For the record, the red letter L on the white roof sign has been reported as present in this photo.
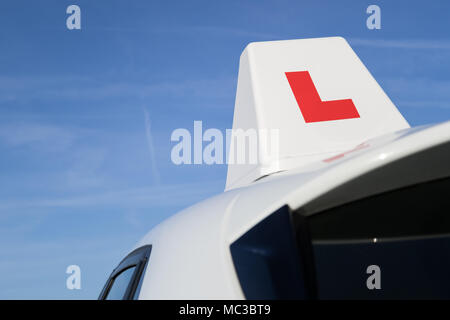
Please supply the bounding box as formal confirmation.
[286,71,359,123]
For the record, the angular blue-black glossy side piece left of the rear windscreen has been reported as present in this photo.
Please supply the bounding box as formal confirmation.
[230,206,306,299]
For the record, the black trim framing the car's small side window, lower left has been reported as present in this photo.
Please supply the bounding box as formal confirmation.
[98,245,152,300]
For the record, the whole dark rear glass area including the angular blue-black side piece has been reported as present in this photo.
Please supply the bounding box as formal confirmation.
[230,177,450,299]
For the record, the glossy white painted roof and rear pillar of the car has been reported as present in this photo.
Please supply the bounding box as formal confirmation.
[119,39,450,299]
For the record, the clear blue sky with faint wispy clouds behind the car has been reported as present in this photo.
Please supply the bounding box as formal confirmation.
[0,0,450,299]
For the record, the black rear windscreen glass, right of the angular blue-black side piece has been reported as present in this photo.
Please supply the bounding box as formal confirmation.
[299,178,450,299]
